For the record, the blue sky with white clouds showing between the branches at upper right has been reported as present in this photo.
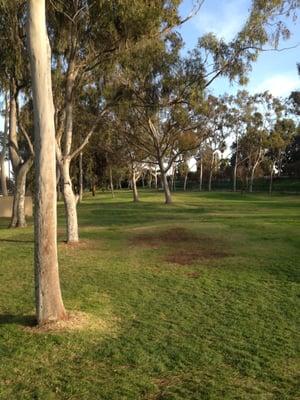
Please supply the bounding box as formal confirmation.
[180,0,300,97]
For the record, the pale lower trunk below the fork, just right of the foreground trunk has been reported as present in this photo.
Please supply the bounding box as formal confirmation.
[59,158,79,243]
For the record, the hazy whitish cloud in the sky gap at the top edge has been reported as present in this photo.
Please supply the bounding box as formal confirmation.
[193,0,249,41]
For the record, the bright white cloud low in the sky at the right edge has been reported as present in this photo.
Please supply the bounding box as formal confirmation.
[251,74,300,97]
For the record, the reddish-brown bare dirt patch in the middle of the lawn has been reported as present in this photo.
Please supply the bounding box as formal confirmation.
[130,227,230,265]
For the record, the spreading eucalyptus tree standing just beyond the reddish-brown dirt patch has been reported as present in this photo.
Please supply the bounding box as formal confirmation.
[113,41,210,204]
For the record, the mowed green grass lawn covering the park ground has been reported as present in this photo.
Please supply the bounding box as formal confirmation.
[0,191,300,400]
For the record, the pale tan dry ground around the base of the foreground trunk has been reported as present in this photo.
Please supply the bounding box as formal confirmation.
[24,311,112,333]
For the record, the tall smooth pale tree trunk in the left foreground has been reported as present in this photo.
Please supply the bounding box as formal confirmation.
[28,0,67,325]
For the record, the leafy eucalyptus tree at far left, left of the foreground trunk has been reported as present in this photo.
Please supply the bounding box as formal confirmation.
[0,0,33,227]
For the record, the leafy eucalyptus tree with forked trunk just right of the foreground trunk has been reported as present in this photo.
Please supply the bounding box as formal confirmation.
[45,0,186,242]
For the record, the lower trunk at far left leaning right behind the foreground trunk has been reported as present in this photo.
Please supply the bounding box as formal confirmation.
[10,158,33,228]
